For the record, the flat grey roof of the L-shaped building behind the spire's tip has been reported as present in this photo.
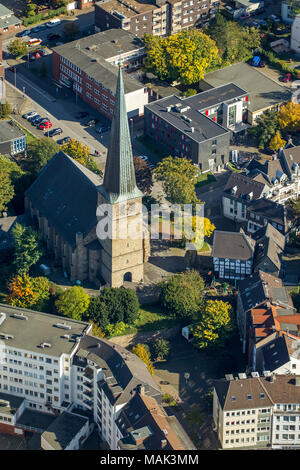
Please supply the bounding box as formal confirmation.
[53,29,144,93]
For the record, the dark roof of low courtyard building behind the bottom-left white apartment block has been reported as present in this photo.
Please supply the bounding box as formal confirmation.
[42,411,88,450]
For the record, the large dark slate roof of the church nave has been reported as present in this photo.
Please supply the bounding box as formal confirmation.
[25,151,102,248]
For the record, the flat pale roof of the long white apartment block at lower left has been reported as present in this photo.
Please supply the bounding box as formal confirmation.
[0,303,89,357]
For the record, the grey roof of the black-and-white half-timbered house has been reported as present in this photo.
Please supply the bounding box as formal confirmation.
[212,230,255,260]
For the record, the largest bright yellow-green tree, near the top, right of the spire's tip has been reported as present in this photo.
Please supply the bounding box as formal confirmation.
[144,29,220,85]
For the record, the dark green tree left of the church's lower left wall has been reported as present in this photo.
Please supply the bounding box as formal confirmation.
[11,224,43,274]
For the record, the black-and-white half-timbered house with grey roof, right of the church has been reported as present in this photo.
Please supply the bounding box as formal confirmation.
[211,230,255,279]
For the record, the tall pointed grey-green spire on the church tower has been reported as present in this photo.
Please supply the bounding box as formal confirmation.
[102,66,143,204]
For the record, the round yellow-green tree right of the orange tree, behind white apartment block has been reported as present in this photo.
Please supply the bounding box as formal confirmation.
[55,286,90,320]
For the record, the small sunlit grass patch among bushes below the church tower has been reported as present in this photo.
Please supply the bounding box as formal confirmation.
[114,303,178,335]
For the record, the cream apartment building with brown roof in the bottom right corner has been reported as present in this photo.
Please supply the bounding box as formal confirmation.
[213,371,300,449]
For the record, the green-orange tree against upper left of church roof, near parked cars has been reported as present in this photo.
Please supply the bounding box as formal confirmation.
[27,137,59,174]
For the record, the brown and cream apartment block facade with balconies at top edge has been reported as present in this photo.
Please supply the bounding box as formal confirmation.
[95,0,214,38]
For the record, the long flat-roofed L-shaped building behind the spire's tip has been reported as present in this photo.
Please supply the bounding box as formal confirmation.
[52,29,148,120]
